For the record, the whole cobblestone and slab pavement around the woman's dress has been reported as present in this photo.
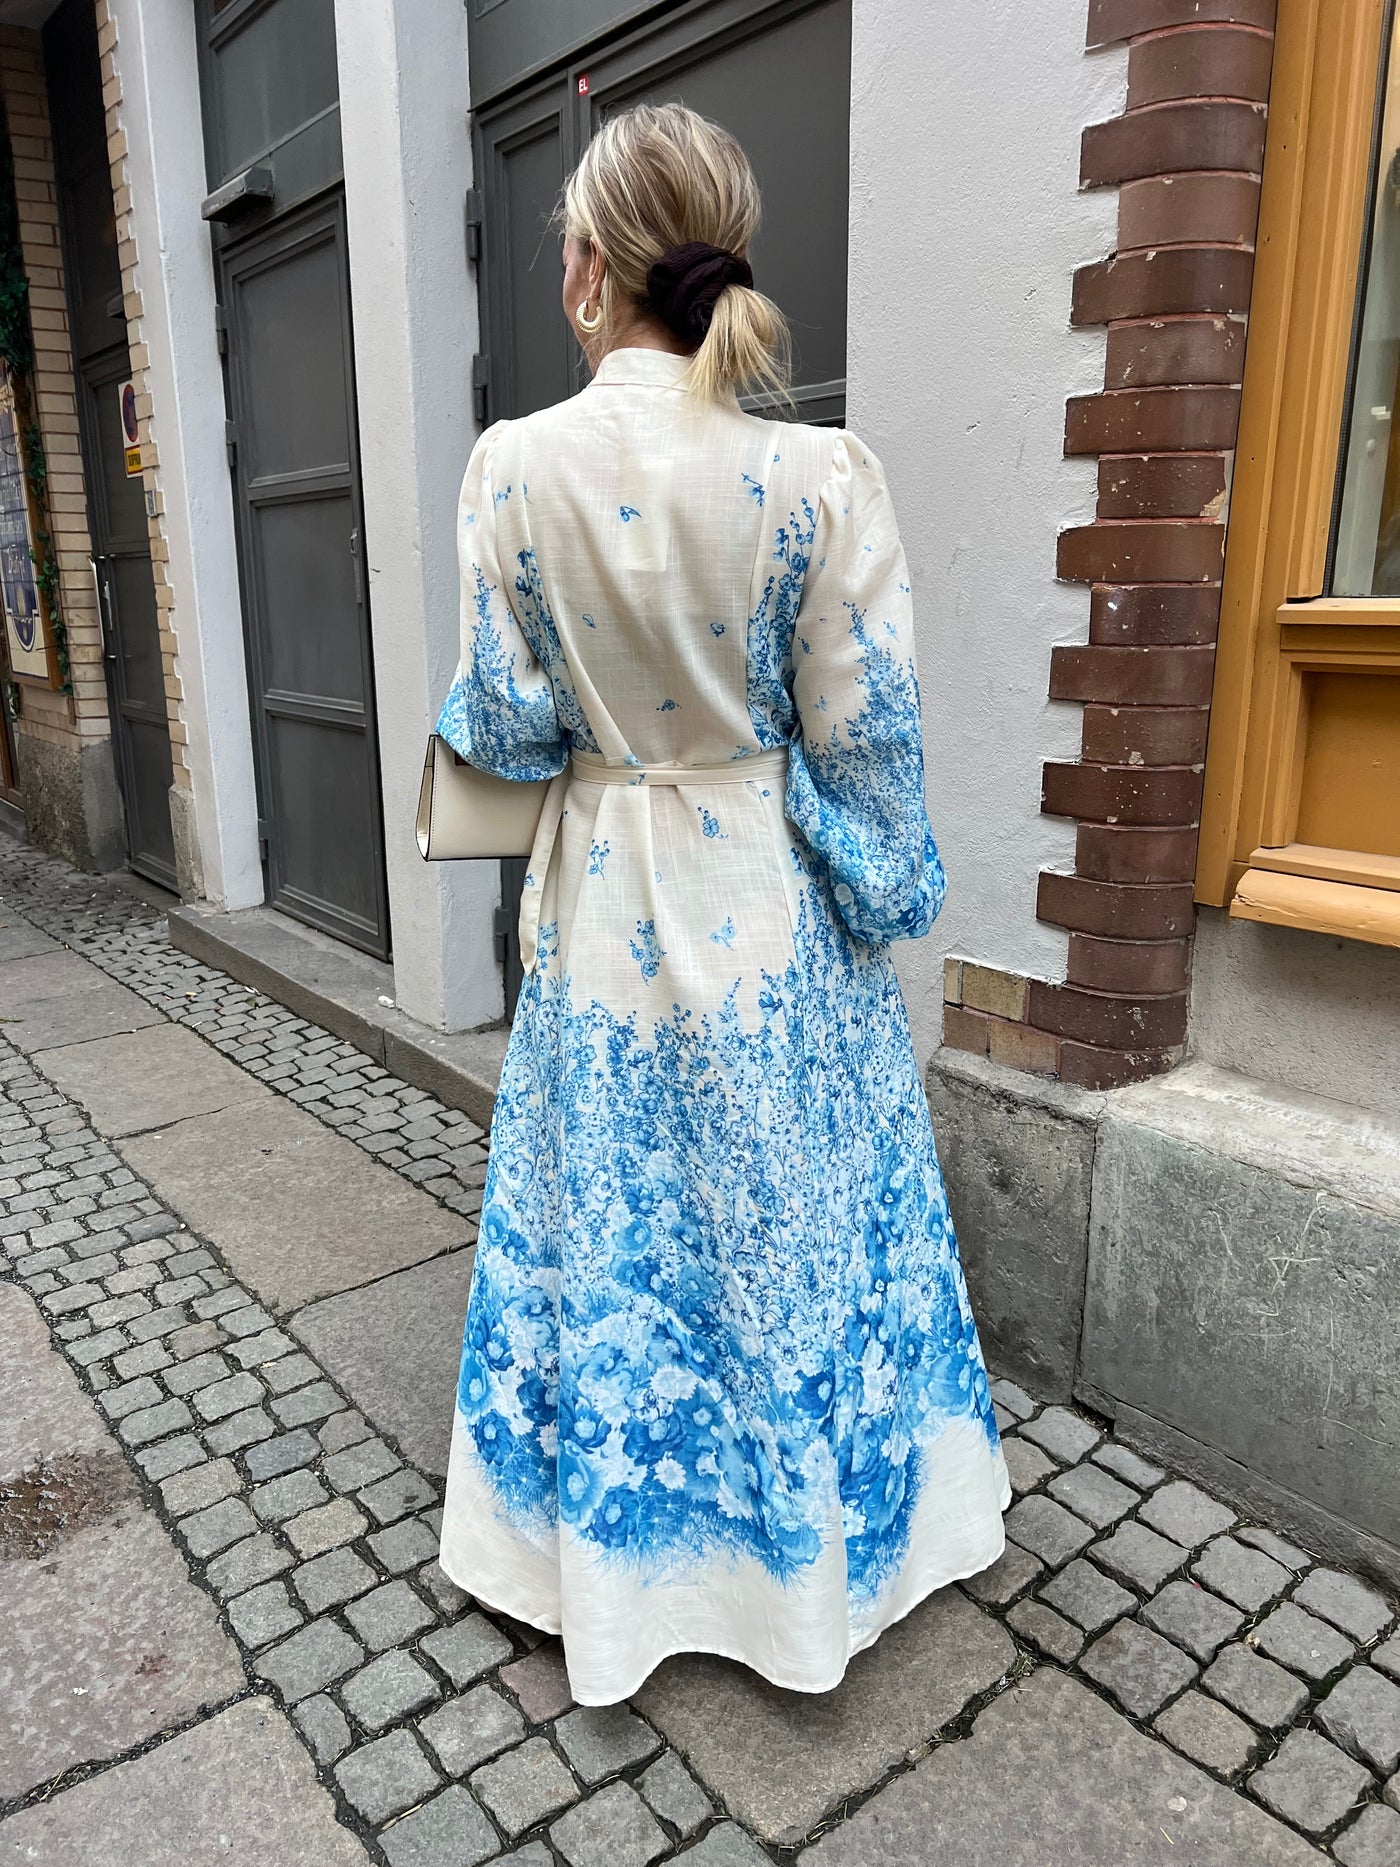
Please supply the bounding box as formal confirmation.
[0,842,1400,1867]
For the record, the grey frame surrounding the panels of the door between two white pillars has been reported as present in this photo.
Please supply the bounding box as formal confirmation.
[215,181,390,960]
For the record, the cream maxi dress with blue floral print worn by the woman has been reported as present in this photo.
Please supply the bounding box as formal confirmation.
[439,349,1010,1705]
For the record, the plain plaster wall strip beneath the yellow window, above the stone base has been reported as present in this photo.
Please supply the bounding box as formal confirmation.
[1189,907,1400,1116]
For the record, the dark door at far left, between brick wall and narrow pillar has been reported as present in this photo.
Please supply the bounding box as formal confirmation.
[43,0,175,889]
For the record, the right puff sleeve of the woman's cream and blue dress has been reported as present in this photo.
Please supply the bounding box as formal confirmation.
[786,433,945,941]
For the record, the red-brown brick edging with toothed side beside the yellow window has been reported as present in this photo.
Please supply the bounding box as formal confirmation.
[945,0,1273,1088]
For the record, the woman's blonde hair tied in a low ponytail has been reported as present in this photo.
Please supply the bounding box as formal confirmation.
[560,105,791,401]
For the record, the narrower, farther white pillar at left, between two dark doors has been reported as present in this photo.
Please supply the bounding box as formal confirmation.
[110,0,263,907]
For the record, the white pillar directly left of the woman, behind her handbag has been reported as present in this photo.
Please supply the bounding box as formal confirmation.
[336,0,504,1031]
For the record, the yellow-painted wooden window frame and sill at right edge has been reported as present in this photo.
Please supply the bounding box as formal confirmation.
[1197,0,1400,947]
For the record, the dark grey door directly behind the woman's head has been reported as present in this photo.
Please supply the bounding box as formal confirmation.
[470,0,851,1008]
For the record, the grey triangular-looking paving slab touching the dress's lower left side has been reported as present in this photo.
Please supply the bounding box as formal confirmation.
[291,1251,474,1477]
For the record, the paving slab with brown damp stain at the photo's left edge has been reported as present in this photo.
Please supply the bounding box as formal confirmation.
[0,1286,245,1799]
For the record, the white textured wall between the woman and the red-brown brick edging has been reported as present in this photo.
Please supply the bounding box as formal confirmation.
[849,0,1126,1060]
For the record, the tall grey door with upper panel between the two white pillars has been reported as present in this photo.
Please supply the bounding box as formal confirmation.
[200,0,388,958]
